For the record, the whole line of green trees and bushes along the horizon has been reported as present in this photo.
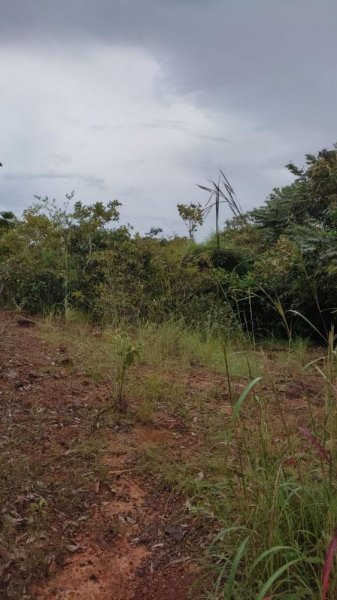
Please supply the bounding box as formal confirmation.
[0,146,337,339]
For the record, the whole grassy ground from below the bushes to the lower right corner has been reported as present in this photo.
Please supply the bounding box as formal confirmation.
[25,319,337,600]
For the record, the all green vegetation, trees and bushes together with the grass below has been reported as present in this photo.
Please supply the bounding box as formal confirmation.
[0,146,337,600]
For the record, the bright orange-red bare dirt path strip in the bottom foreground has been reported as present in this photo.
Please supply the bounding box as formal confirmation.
[36,426,197,600]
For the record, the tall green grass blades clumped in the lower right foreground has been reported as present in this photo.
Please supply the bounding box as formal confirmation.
[201,322,337,600]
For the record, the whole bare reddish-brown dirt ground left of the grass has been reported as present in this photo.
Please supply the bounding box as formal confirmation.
[0,313,201,600]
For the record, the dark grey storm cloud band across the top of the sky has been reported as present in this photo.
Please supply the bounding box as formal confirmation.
[0,0,337,155]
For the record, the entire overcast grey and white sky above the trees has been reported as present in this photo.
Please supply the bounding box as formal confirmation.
[0,0,337,234]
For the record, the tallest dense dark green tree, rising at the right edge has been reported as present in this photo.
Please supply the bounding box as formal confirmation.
[219,146,337,336]
